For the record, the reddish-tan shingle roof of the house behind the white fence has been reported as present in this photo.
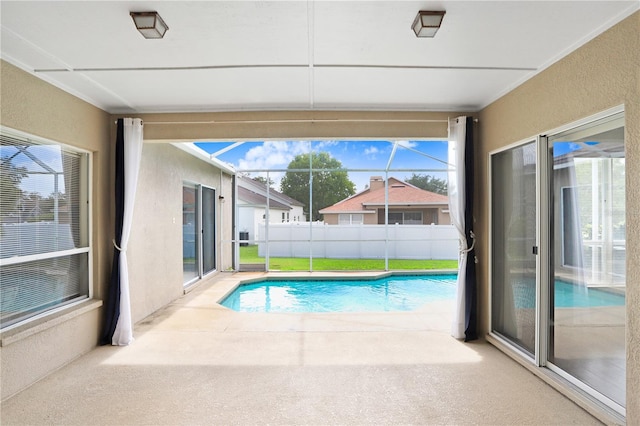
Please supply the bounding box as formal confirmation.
[320,177,449,214]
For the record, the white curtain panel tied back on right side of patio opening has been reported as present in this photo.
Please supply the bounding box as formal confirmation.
[448,116,468,339]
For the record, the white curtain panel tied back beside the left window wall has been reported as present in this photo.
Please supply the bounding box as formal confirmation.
[111,118,143,346]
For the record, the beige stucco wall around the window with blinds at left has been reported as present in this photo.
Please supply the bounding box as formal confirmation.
[0,61,112,399]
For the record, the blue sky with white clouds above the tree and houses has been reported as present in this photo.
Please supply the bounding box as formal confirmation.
[196,140,448,191]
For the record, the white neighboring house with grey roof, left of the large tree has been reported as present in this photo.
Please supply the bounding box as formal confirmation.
[237,176,307,240]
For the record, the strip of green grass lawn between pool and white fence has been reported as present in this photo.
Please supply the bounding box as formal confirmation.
[240,245,458,271]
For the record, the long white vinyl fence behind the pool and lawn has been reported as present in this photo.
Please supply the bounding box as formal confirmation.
[257,222,459,260]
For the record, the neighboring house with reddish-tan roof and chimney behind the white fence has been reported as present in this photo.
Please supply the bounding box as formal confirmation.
[320,176,451,225]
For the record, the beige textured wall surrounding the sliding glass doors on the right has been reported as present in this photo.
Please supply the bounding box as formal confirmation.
[475,12,640,424]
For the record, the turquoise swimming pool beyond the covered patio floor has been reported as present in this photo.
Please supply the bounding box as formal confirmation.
[220,274,457,312]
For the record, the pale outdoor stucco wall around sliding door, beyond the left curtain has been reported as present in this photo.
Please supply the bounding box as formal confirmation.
[127,143,233,322]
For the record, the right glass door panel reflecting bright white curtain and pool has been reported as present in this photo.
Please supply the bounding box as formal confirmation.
[548,118,626,407]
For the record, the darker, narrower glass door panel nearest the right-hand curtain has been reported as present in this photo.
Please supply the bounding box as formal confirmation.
[491,142,537,357]
